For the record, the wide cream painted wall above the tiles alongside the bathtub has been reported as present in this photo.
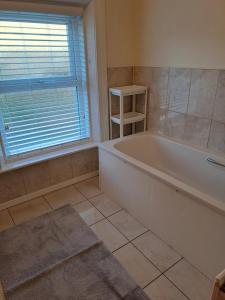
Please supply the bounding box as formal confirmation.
[134,0,225,69]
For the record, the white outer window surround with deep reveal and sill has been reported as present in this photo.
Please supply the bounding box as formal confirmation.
[0,0,109,173]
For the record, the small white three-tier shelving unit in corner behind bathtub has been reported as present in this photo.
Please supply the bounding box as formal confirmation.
[109,85,148,139]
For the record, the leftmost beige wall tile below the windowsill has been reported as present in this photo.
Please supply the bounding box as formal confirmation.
[0,170,26,203]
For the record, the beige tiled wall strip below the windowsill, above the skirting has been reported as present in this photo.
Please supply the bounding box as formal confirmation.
[0,148,98,204]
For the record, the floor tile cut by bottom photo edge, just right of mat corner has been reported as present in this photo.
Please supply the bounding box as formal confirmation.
[144,275,188,300]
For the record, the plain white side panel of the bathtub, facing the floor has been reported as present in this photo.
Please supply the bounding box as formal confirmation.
[100,149,225,279]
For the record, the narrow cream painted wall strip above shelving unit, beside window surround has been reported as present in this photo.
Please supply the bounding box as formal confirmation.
[106,0,135,67]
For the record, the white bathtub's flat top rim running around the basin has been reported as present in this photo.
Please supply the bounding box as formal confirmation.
[99,132,225,216]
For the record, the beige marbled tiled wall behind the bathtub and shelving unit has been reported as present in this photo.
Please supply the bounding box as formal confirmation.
[108,67,225,153]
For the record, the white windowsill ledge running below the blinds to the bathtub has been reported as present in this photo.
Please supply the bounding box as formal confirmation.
[0,141,98,174]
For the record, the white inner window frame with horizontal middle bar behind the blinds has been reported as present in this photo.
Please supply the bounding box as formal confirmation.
[0,11,93,166]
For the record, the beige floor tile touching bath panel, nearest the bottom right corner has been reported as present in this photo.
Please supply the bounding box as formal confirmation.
[165,260,213,300]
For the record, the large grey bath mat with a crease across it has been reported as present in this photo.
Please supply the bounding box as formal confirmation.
[0,206,151,300]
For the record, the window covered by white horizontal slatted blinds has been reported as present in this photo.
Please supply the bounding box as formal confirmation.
[0,12,90,159]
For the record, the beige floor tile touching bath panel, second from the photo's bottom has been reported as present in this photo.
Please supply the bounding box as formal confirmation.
[132,232,181,272]
